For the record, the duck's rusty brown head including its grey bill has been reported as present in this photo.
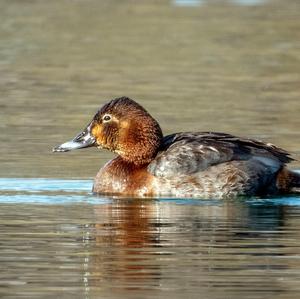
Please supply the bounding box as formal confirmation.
[54,97,162,165]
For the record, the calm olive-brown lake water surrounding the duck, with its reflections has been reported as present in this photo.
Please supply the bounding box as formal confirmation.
[0,0,300,299]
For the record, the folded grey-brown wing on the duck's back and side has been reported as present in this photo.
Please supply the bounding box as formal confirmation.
[148,132,293,177]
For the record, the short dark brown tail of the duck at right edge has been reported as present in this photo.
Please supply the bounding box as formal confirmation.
[276,167,300,193]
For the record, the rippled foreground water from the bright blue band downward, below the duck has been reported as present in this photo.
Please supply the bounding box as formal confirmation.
[0,179,300,299]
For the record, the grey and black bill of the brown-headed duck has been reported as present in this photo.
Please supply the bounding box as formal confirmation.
[53,123,96,152]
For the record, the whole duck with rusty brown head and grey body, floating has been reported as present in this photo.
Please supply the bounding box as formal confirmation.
[53,97,300,199]
